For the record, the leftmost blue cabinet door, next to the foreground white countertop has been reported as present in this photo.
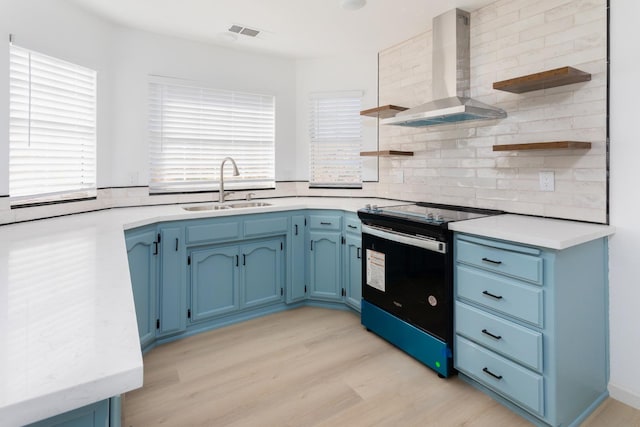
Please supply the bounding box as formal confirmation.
[126,226,158,348]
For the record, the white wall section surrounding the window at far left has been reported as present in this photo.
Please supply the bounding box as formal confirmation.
[0,0,112,195]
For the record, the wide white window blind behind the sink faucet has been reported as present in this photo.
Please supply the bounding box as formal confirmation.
[149,78,275,193]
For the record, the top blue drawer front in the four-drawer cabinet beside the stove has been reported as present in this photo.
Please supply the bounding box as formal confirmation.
[456,240,542,285]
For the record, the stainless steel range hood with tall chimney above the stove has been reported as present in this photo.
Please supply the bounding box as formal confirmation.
[380,9,507,127]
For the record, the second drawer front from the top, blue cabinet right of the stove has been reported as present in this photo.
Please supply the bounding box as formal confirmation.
[455,264,543,327]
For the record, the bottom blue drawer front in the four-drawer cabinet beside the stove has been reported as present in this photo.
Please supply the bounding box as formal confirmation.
[454,335,544,416]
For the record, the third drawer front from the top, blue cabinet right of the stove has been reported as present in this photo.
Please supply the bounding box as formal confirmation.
[455,302,542,373]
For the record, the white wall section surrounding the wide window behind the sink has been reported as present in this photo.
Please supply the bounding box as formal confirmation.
[111,28,298,186]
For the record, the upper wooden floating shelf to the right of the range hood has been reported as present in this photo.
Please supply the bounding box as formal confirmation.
[493,67,591,93]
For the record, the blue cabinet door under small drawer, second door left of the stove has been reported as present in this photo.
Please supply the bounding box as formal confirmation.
[309,231,342,301]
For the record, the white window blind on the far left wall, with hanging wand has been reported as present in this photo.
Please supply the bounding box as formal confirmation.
[9,44,96,205]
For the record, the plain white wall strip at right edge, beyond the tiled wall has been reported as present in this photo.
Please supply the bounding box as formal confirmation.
[609,0,640,408]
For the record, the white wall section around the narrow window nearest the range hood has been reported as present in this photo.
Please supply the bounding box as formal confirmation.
[292,52,378,181]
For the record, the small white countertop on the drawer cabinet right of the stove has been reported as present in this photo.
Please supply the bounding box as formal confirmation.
[449,214,615,250]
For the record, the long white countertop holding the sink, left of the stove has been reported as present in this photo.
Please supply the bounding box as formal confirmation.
[0,198,397,427]
